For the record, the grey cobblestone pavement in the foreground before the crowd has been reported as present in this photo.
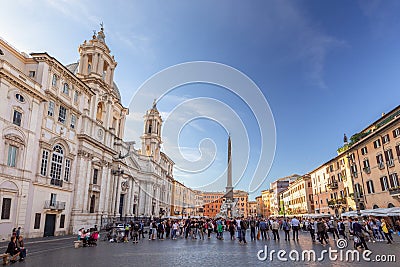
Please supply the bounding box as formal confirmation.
[14,231,400,267]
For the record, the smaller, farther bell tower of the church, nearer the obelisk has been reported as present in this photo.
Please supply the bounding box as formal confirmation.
[141,100,162,162]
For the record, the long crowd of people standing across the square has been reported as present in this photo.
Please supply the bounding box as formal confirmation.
[101,217,400,249]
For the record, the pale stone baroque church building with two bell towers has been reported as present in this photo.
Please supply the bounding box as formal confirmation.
[0,27,176,239]
